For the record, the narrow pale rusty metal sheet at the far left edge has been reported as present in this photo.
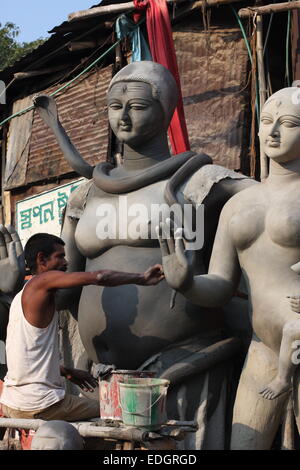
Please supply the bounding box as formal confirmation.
[4,96,33,189]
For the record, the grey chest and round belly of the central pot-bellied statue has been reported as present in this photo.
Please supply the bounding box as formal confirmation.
[75,181,218,369]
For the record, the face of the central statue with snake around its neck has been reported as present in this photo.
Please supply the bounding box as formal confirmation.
[107,82,164,148]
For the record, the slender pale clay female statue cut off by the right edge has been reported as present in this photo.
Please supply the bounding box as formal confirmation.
[162,87,300,449]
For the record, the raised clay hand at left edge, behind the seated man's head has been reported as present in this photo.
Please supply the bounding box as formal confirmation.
[0,225,25,293]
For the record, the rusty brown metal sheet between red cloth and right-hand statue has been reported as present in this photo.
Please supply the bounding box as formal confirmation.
[173,28,249,170]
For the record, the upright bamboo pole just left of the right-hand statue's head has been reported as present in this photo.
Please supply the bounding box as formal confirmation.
[256,15,268,181]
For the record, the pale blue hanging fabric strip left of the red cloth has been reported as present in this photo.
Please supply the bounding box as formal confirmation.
[115,15,152,62]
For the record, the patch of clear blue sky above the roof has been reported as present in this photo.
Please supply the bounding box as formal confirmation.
[0,0,100,42]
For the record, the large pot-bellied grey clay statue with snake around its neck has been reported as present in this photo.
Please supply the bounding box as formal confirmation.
[35,61,254,448]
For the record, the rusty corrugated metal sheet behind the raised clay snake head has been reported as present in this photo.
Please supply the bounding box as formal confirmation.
[26,66,112,184]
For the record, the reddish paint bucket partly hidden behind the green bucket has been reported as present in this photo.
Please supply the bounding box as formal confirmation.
[99,370,155,421]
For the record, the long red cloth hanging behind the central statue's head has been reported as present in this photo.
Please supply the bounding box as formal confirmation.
[133,0,190,155]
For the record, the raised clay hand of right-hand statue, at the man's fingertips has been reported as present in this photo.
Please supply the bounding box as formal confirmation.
[156,219,193,290]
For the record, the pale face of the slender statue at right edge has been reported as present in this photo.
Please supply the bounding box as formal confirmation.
[259,95,300,163]
